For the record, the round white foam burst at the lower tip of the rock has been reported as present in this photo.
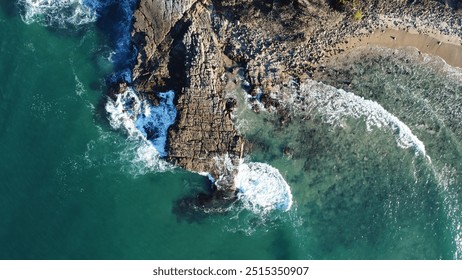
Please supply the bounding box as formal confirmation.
[235,162,292,213]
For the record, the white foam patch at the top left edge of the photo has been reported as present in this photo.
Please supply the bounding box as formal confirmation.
[18,0,98,27]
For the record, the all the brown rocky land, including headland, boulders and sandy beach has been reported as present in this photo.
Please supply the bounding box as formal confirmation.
[114,0,462,196]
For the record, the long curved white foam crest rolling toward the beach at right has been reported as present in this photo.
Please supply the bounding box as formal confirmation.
[296,80,430,160]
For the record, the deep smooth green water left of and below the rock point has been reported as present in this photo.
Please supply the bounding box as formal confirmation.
[0,1,297,259]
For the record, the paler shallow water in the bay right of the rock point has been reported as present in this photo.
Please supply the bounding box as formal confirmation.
[231,44,462,259]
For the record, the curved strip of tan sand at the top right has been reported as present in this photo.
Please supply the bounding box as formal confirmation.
[327,28,462,68]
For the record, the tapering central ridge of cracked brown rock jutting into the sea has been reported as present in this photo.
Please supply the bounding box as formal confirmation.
[168,2,243,189]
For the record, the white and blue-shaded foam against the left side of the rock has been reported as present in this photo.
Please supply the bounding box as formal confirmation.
[106,88,176,171]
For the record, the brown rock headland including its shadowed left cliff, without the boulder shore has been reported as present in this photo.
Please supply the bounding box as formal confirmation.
[133,1,244,193]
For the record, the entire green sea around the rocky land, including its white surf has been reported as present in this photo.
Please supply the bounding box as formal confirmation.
[0,0,462,259]
